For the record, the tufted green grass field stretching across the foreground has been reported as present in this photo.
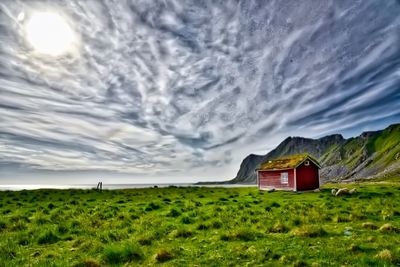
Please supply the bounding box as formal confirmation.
[0,179,400,266]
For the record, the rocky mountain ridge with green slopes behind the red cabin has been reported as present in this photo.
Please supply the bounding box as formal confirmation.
[229,124,400,184]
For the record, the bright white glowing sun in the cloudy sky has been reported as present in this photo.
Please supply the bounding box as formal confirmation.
[25,12,76,56]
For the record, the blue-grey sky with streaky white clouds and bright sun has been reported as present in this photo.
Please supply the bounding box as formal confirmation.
[0,0,400,184]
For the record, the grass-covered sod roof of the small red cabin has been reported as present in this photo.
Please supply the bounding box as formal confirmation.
[257,154,320,170]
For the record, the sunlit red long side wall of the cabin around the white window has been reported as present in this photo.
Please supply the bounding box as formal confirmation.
[258,169,294,190]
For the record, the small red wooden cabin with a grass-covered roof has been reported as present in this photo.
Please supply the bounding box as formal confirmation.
[256,154,321,191]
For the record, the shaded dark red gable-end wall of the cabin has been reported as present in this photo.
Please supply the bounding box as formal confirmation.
[296,161,319,191]
